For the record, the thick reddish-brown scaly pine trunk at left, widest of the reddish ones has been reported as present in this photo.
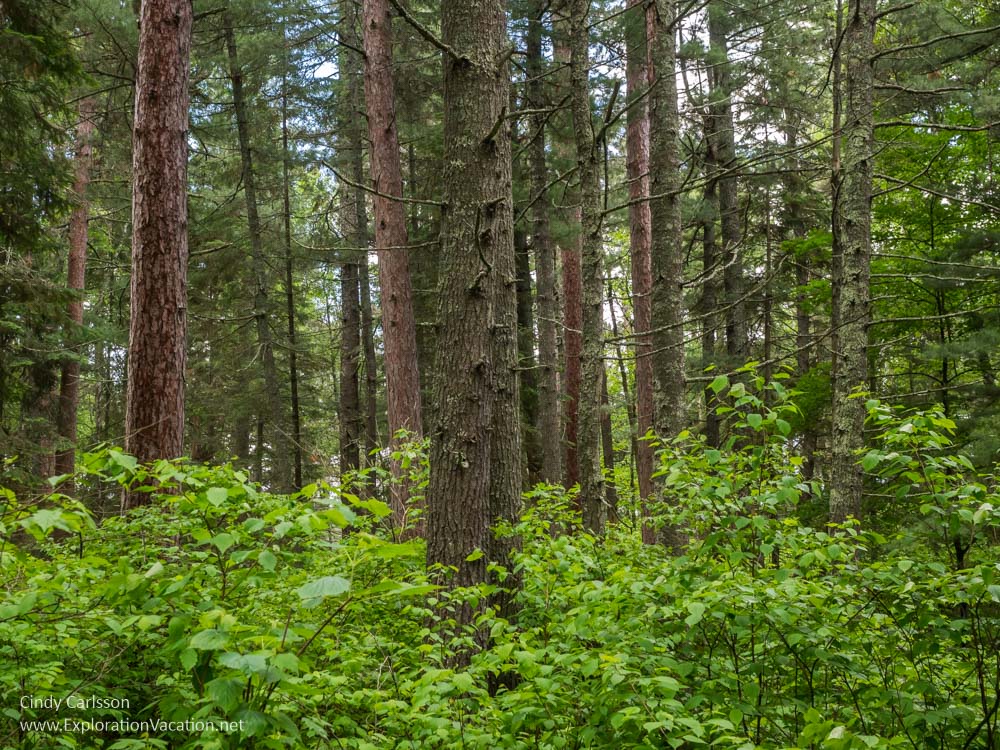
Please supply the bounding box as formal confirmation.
[123,0,192,509]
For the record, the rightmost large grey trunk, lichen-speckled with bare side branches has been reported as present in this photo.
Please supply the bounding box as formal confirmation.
[830,0,876,523]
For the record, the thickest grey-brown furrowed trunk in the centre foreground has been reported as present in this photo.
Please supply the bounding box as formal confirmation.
[427,0,521,622]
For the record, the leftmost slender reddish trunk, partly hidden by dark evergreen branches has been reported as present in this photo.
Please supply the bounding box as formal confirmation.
[55,97,94,482]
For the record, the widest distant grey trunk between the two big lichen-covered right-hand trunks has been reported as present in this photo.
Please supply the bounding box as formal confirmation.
[708,0,749,365]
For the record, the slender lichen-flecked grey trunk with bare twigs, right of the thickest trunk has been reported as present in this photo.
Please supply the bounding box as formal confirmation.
[570,0,607,534]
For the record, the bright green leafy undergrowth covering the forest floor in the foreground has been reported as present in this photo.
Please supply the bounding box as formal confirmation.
[0,400,1000,750]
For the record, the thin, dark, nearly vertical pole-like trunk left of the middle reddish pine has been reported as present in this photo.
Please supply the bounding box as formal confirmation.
[281,32,302,490]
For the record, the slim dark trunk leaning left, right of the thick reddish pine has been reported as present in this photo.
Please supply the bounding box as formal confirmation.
[223,14,290,491]
